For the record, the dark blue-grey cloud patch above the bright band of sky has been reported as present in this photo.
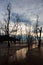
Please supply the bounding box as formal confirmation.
[11,13,31,24]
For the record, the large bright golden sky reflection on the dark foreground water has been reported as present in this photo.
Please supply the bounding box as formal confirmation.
[16,48,28,60]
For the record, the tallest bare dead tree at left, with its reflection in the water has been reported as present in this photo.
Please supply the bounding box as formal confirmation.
[7,3,11,59]
